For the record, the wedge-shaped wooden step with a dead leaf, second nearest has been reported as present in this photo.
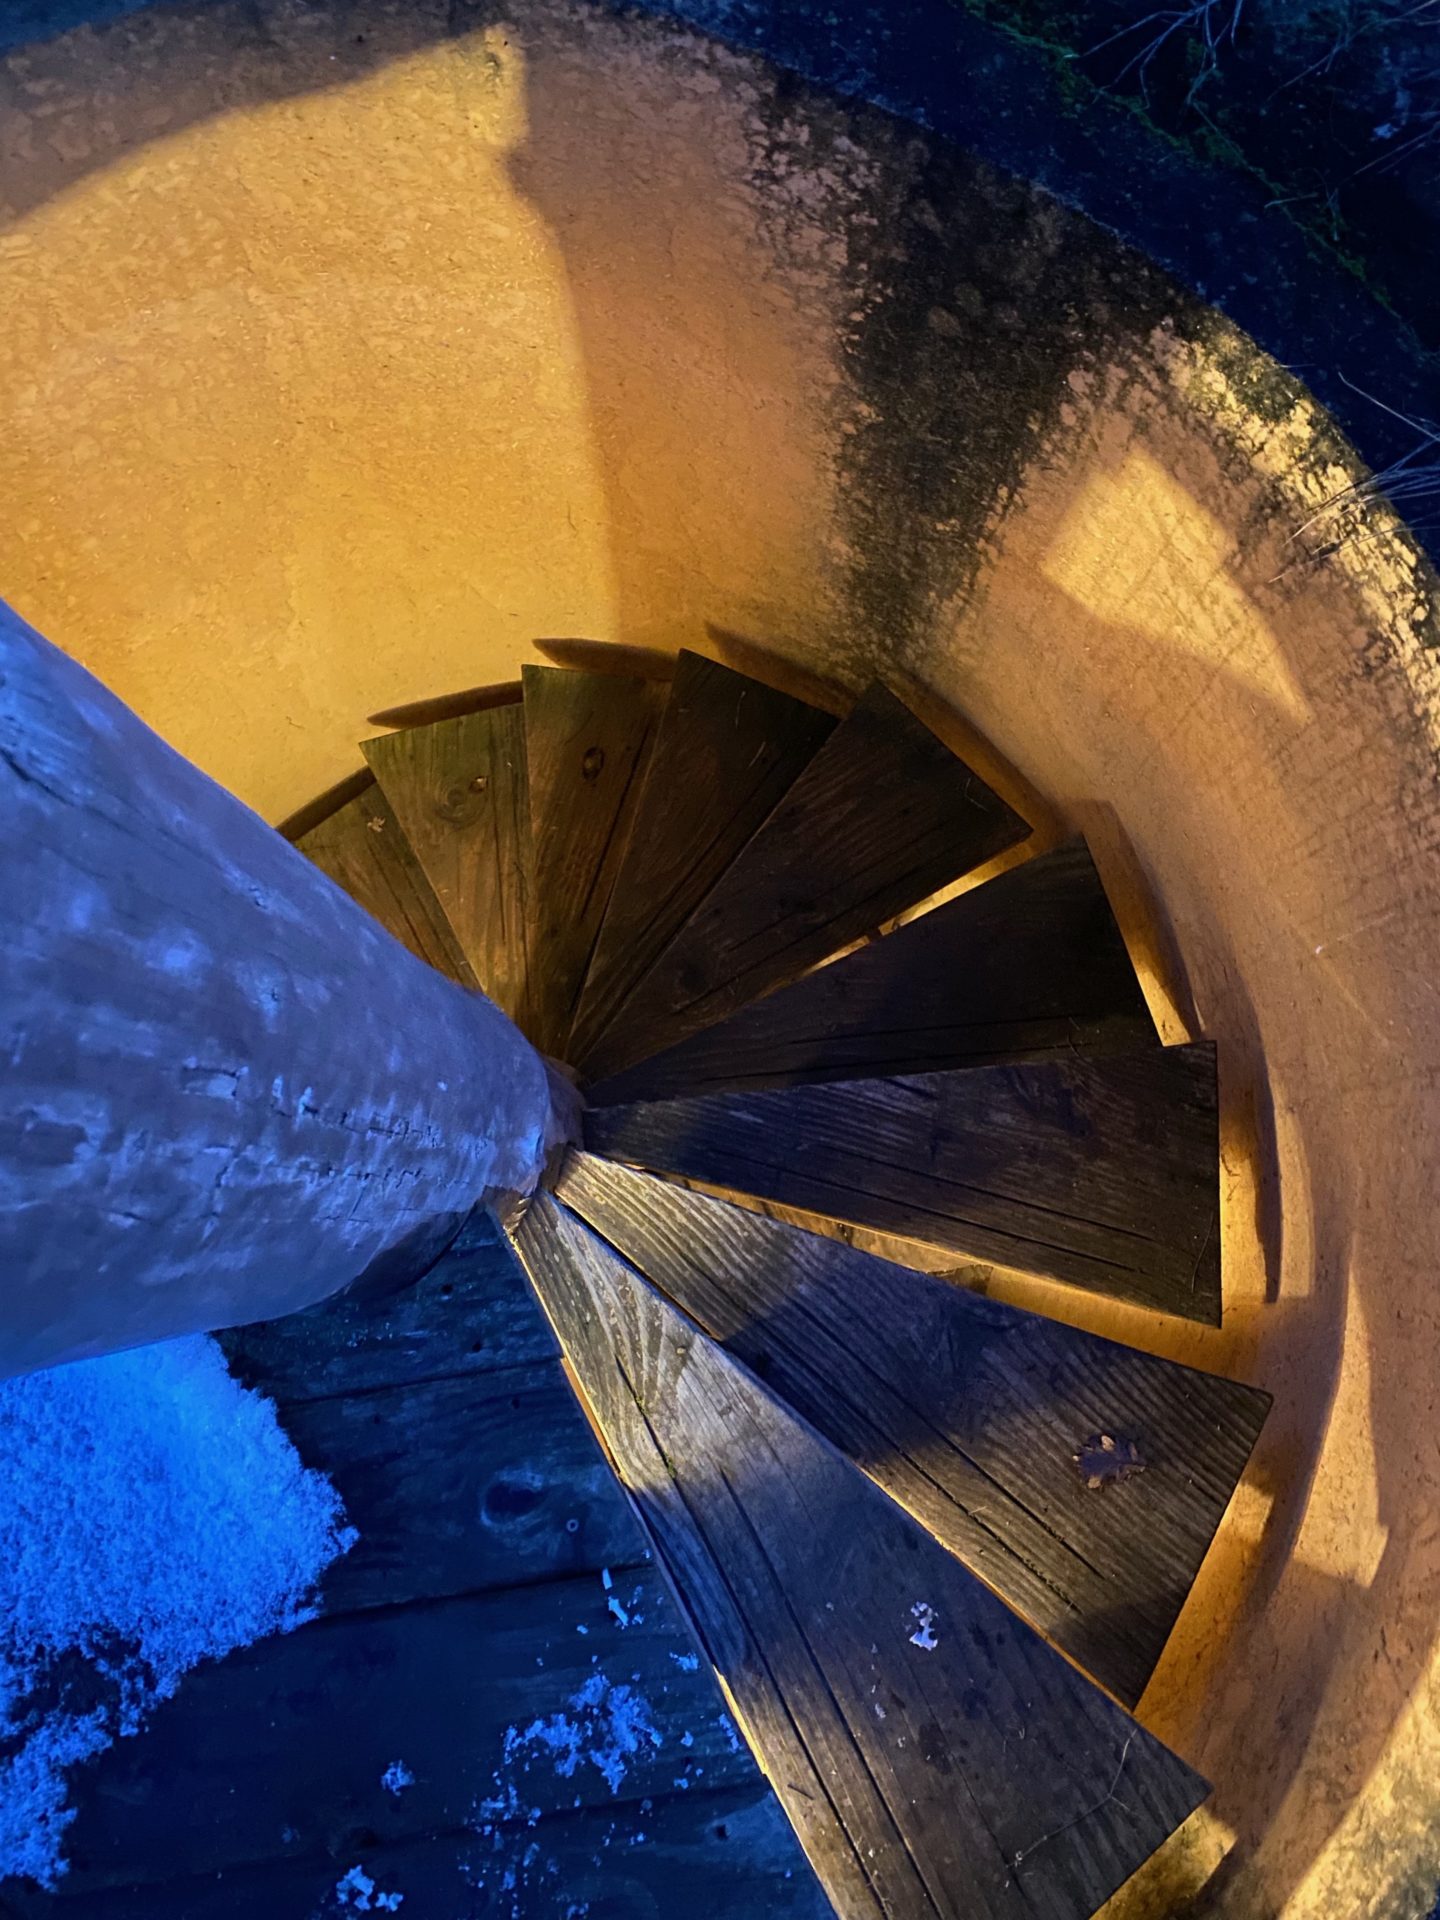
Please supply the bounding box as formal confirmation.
[557,1154,1269,1705]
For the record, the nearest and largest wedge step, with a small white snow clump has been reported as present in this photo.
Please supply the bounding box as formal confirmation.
[516,1194,1206,1920]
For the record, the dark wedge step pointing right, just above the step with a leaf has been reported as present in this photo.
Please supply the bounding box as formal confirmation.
[586,1043,1219,1325]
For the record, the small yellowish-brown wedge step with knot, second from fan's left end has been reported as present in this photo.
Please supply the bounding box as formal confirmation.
[361,705,530,1018]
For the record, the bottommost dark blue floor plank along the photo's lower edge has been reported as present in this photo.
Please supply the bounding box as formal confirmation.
[28,1782,831,1920]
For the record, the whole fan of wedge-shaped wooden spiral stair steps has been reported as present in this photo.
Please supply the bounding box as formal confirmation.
[296,647,1267,1920]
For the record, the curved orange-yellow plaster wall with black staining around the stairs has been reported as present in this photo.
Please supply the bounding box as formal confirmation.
[0,0,1440,1920]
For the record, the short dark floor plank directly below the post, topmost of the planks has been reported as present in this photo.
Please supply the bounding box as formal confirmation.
[219,1215,559,1405]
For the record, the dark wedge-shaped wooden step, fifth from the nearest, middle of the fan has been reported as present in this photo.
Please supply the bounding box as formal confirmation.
[580,684,1029,1081]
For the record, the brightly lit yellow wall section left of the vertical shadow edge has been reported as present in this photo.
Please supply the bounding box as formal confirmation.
[0,4,629,818]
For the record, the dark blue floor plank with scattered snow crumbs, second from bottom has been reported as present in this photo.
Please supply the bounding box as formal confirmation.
[48,1569,756,1895]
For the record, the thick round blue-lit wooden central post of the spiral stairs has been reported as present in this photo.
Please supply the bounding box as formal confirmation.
[0,607,555,1377]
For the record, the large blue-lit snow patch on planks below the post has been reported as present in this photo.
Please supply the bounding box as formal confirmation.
[0,1336,357,1887]
